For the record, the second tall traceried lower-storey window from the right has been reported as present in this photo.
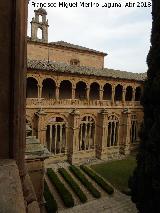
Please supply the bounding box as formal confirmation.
[107,115,119,147]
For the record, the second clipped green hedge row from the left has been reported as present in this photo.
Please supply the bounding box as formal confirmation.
[47,168,74,207]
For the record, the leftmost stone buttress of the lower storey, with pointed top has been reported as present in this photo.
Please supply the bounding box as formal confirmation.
[35,109,46,146]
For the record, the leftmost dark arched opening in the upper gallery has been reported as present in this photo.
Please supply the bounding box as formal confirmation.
[26,77,38,98]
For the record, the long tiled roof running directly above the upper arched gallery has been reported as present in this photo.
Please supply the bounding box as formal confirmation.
[27,60,147,81]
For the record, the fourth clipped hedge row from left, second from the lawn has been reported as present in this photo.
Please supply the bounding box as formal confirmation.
[69,165,101,198]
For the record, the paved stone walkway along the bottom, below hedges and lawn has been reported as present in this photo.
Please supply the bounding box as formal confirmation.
[58,191,138,213]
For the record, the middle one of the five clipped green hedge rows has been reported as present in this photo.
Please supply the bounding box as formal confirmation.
[58,168,87,203]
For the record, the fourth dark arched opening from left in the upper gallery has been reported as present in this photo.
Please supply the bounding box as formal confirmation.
[75,81,87,100]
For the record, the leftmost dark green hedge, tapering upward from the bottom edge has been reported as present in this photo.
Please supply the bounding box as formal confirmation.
[43,181,58,213]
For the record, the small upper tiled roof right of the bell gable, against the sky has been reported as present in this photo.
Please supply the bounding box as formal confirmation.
[49,41,107,56]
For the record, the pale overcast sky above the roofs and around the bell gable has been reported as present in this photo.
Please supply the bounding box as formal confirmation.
[28,0,151,72]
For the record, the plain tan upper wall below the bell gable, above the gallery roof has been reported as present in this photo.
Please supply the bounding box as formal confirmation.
[27,41,104,69]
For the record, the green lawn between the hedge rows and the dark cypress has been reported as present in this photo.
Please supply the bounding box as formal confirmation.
[91,156,136,192]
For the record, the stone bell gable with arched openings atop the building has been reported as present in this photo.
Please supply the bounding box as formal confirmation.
[31,8,49,43]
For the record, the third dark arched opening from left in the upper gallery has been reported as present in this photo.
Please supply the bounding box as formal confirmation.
[59,80,72,99]
